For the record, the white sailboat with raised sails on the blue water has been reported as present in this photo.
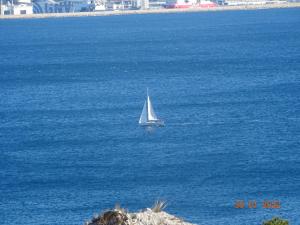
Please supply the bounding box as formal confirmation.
[139,88,165,127]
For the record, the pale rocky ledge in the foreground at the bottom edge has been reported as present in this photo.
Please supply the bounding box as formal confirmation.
[85,208,194,225]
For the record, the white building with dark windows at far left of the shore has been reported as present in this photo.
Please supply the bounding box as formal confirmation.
[0,0,33,15]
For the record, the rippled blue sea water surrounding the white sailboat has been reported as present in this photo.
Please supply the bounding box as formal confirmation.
[0,9,300,225]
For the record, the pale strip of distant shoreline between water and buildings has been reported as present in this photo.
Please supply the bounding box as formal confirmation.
[0,3,300,19]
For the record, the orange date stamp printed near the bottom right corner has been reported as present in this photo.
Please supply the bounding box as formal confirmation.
[234,200,281,209]
